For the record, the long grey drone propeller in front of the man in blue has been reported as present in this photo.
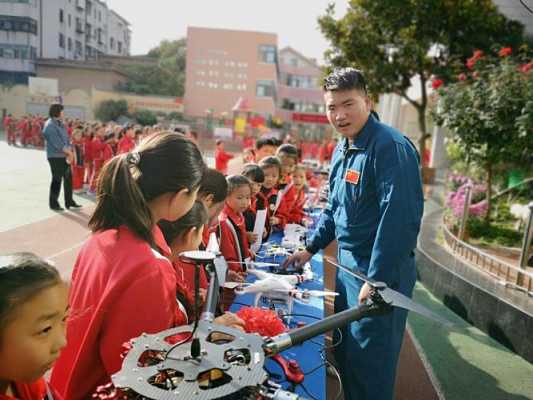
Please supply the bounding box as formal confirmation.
[326,257,452,327]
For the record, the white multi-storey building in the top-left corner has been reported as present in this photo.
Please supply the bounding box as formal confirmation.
[0,0,131,83]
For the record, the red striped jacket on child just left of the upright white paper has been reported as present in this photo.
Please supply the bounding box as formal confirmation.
[219,204,250,272]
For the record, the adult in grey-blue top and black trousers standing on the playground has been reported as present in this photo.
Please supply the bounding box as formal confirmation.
[43,103,81,211]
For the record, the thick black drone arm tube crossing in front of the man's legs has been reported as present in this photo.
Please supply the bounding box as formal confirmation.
[264,303,391,356]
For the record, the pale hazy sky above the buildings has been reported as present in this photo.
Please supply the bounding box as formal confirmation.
[107,0,348,61]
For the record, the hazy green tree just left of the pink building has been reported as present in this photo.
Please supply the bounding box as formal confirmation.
[123,39,187,97]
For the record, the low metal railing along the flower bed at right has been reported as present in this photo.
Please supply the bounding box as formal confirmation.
[442,221,533,296]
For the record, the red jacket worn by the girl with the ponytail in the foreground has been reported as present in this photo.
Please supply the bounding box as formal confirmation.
[51,226,187,400]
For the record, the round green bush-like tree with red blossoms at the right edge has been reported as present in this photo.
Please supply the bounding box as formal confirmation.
[434,48,533,221]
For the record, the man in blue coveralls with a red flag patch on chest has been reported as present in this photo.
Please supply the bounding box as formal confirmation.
[286,68,424,400]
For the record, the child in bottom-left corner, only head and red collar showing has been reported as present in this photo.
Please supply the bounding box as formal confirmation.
[0,253,68,400]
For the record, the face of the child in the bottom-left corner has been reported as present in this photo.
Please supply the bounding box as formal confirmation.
[0,283,68,383]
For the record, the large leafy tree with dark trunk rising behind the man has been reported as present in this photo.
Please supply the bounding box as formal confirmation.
[318,0,523,164]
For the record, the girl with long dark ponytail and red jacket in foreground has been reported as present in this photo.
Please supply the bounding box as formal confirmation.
[51,132,242,400]
